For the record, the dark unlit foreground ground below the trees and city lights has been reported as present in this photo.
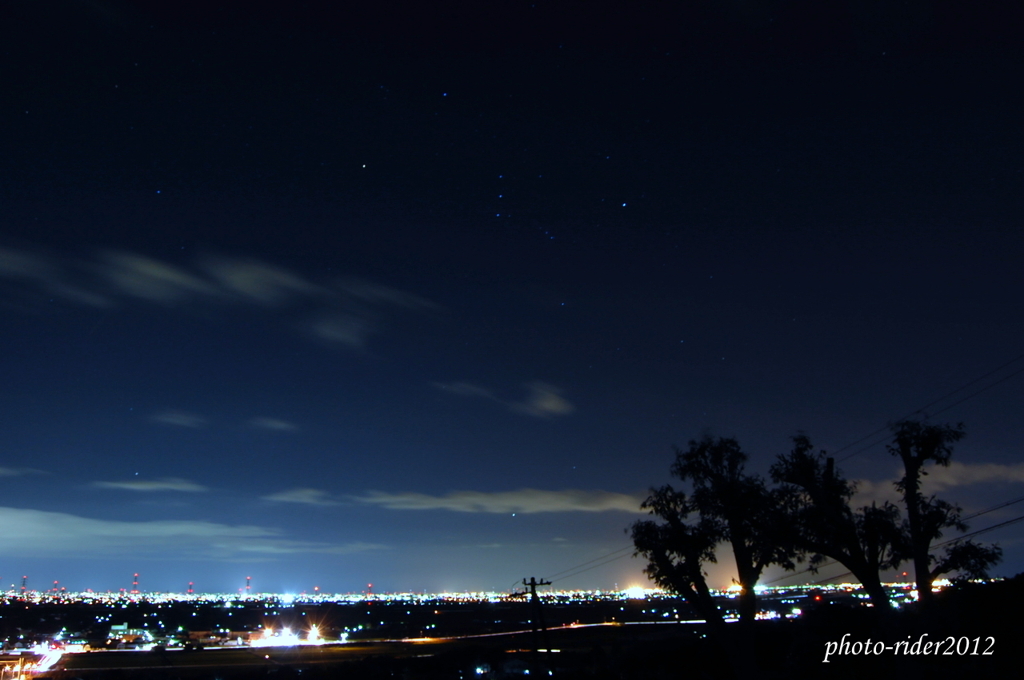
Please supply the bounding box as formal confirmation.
[9,577,1024,680]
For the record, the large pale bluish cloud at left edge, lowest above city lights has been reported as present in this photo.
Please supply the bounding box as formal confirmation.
[0,508,385,560]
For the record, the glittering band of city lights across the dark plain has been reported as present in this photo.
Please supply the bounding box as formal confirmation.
[0,583,958,675]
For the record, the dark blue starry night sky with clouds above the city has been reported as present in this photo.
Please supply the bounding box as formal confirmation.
[0,0,1024,592]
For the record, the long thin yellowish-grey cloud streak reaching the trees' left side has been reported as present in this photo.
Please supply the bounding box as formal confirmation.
[356,488,644,514]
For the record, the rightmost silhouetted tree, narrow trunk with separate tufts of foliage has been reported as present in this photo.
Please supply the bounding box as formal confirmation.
[888,420,1002,604]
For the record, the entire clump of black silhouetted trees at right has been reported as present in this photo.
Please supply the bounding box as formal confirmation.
[631,421,1002,627]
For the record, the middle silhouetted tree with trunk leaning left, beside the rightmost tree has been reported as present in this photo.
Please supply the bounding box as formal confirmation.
[771,434,907,610]
